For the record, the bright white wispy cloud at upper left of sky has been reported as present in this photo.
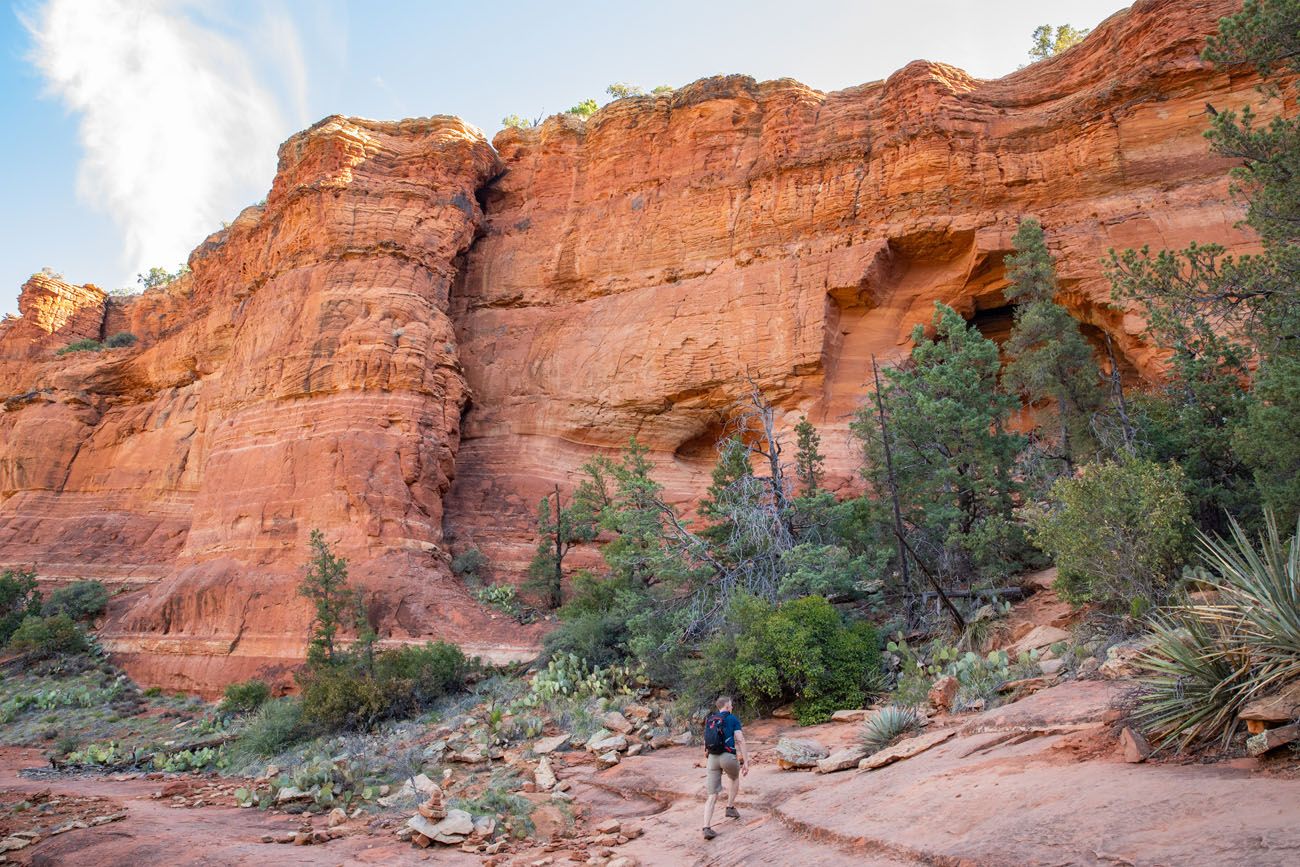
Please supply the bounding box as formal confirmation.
[26,0,307,284]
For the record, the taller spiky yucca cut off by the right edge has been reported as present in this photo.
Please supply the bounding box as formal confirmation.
[1200,510,1300,692]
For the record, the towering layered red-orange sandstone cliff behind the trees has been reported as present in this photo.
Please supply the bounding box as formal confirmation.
[0,0,1279,689]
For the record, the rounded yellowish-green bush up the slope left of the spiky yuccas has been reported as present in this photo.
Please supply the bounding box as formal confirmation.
[1024,459,1191,614]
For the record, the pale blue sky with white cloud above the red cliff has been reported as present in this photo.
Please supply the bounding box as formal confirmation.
[0,0,1127,313]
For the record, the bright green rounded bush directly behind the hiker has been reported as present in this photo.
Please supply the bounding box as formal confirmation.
[693,597,880,725]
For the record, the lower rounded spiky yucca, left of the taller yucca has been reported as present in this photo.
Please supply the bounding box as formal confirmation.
[1135,608,1251,751]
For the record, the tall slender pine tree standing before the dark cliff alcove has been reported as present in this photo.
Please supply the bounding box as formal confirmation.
[1002,217,1105,473]
